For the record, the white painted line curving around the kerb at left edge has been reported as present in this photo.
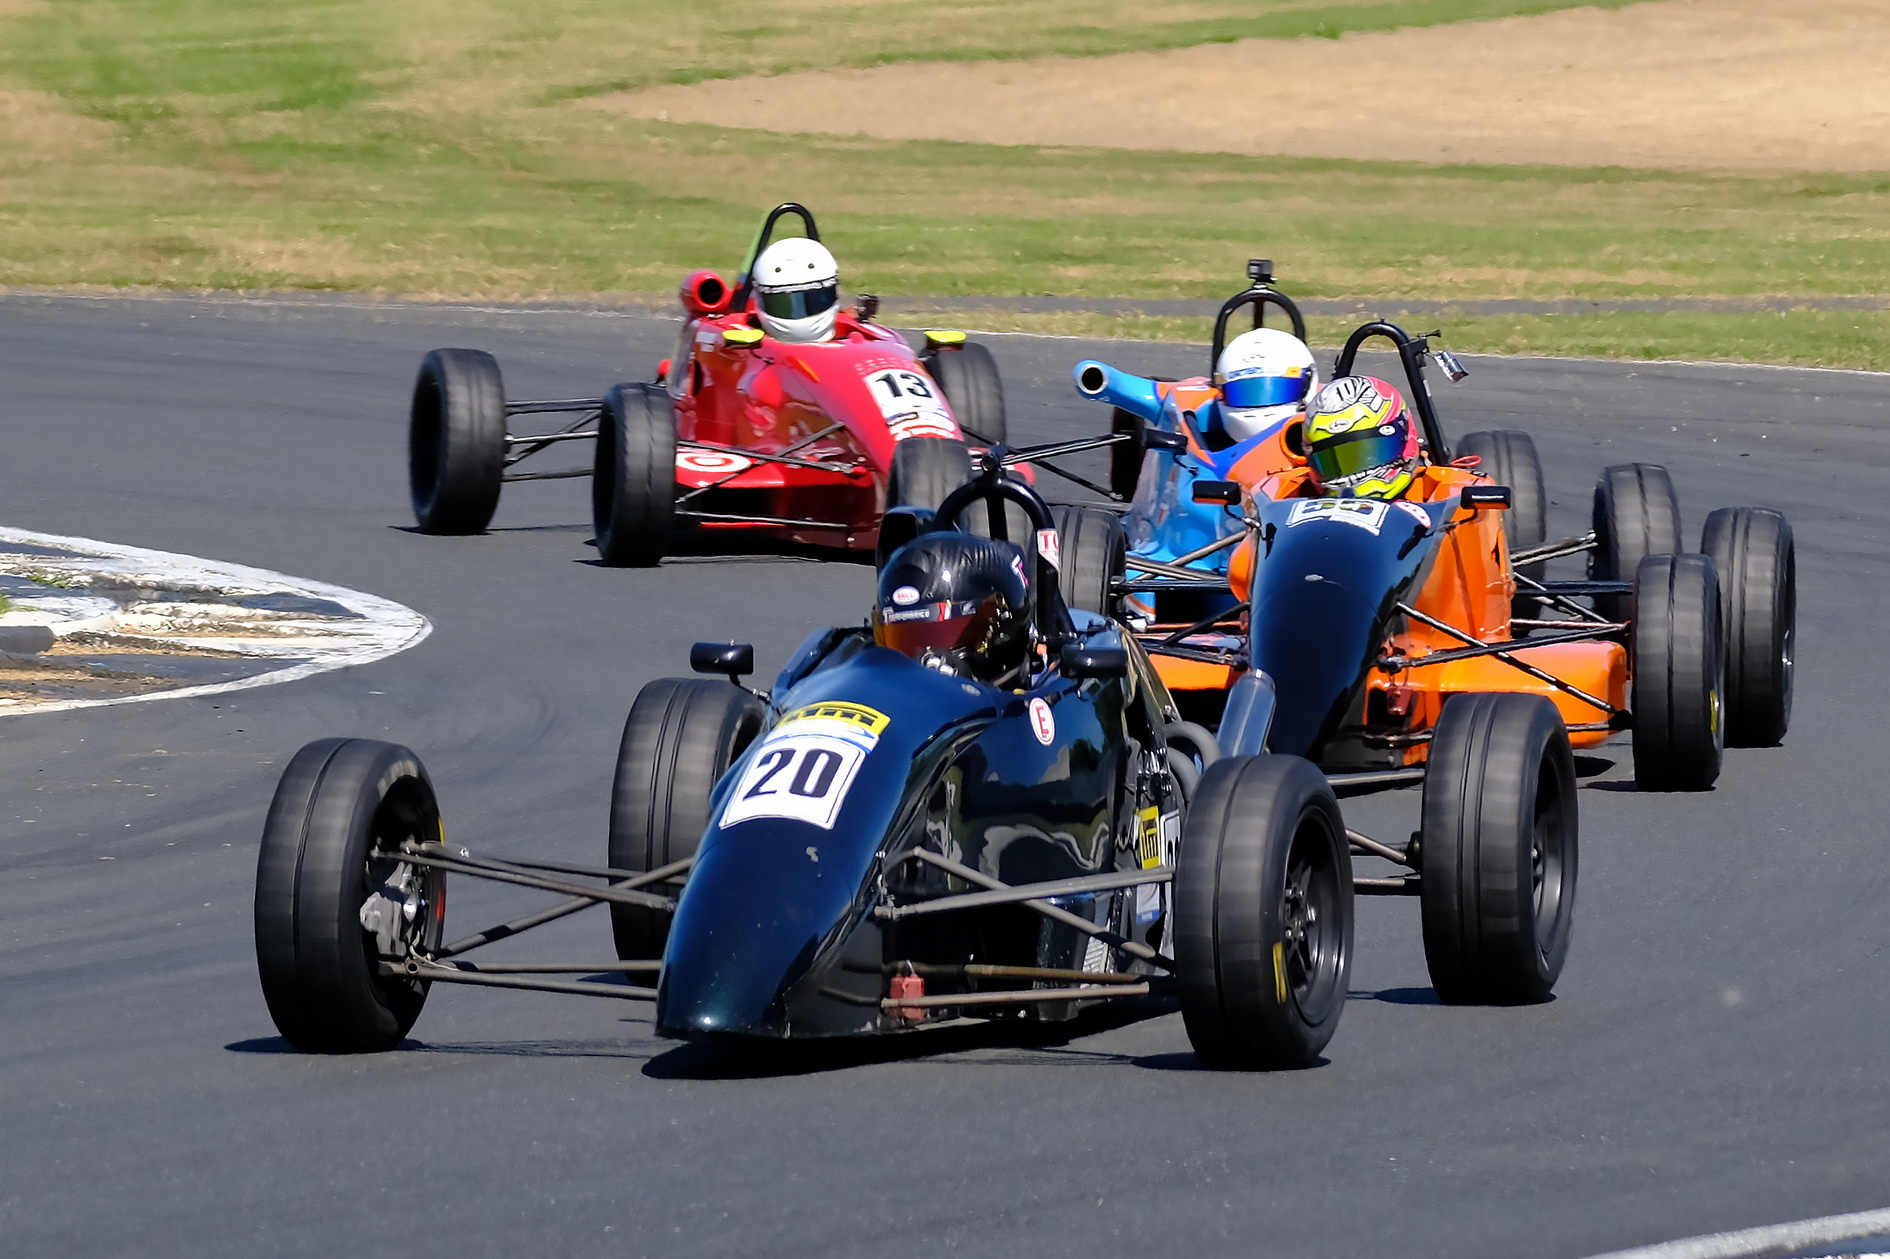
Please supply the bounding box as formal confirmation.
[0,527,433,716]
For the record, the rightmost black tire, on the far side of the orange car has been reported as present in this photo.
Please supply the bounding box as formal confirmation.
[1699,507,1797,747]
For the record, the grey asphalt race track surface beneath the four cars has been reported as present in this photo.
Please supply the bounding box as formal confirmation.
[0,299,1890,1259]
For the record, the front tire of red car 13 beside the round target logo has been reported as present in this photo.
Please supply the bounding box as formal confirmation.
[592,384,677,569]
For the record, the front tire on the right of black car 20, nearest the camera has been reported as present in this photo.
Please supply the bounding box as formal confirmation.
[1174,756,1353,1070]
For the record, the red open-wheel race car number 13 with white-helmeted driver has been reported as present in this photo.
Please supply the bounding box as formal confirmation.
[408,202,1005,565]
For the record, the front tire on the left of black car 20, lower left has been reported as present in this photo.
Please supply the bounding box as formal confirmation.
[255,739,446,1053]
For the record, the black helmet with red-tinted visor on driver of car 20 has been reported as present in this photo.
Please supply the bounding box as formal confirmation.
[873,531,1030,682]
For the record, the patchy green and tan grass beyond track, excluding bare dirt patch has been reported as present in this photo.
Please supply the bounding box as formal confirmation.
[0,0,1890,365]
